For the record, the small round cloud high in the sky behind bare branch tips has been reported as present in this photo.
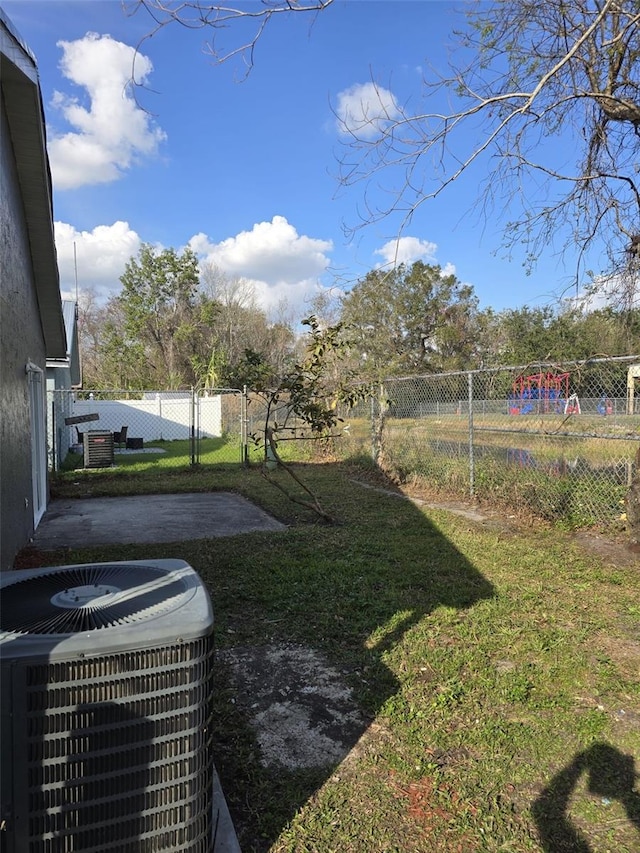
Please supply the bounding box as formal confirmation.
[336,83,400,139]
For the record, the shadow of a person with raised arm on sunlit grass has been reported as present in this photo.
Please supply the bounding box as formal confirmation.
[532,743,640,853]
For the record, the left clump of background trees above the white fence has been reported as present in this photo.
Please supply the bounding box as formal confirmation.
[79,245,296,391]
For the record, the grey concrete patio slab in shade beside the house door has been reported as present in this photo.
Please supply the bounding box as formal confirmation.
[33,492,286,551]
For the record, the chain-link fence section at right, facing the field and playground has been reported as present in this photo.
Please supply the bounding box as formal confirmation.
[337,356,640,530]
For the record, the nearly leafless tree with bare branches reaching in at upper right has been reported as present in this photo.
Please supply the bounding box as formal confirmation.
[341,0,640,292]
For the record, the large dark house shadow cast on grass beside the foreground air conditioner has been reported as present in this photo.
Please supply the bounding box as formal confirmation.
[204,465,494,853]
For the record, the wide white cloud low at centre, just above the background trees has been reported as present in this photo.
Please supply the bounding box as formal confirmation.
[189,216,333,313]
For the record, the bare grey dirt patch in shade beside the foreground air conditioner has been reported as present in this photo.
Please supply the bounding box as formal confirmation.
[218,644,368,770]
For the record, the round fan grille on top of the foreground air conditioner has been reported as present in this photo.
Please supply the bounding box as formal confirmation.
[0,563,186,634]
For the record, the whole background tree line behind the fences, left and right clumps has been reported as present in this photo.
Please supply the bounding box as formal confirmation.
[79,245,640,390]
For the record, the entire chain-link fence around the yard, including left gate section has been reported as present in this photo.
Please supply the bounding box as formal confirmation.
[49,355,640,531]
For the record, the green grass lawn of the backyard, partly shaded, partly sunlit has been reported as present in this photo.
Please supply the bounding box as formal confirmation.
[41,443,640,853]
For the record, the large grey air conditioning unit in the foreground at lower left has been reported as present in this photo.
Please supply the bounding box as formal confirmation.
[0,560,217,853]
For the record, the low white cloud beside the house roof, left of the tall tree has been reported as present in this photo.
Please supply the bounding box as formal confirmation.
[55,221,141,300]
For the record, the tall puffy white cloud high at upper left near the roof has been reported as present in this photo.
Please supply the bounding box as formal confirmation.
[49,33,166,190]
